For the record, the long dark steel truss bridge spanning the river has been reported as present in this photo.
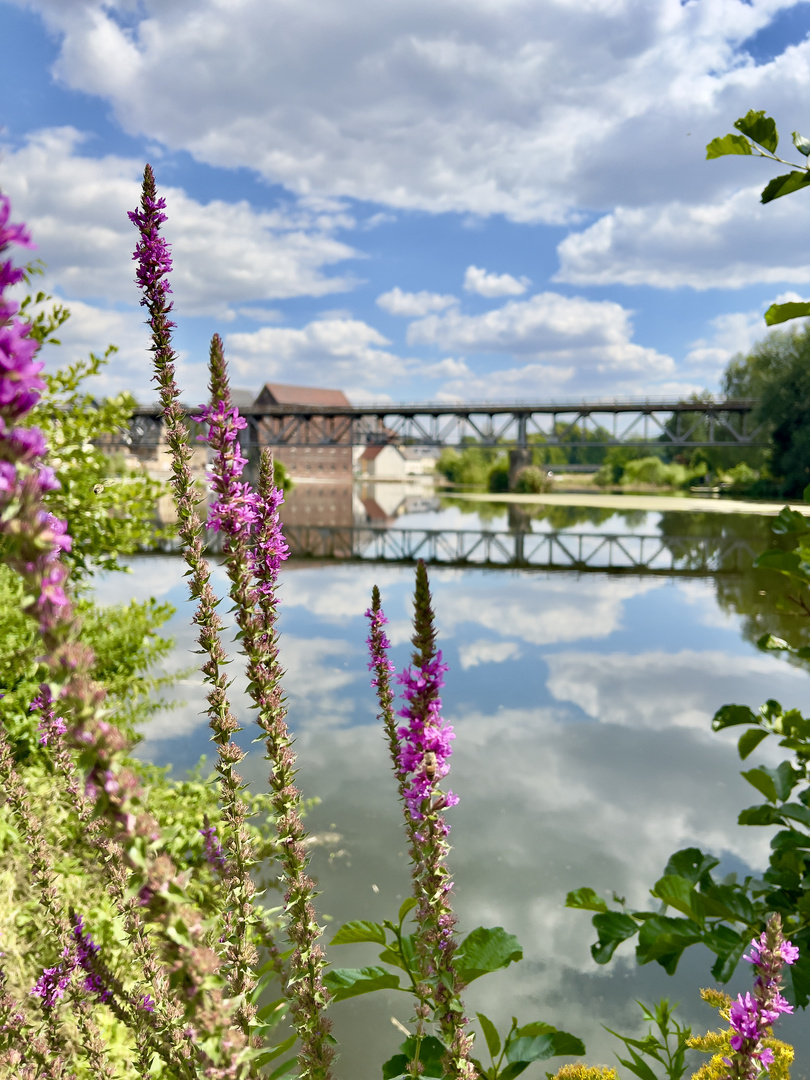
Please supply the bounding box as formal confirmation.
[124,401,766,449]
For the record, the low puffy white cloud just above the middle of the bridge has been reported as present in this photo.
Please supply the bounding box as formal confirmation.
[407,293,675,400]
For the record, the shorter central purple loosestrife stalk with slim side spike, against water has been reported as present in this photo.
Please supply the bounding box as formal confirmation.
[366,561,476,1080]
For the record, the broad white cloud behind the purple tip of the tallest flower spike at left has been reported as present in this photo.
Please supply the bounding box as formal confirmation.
[0,127,357,319]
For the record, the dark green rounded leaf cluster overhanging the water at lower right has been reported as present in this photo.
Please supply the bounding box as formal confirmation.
[566,682,810,1009]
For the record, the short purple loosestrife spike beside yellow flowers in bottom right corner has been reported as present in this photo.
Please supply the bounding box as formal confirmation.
[724,914,799,1080]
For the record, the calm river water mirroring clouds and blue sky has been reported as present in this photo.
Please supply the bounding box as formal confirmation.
[98,504,810,1080]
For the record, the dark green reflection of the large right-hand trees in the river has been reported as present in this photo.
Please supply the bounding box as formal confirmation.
[659,513,810,652]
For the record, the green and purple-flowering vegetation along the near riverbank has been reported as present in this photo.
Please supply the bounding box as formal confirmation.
[0,132,810,1080]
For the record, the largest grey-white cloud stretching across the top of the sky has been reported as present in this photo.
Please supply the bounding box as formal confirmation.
[15,0,810,222]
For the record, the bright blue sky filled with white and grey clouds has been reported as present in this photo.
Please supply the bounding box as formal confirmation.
[0,0,810,402]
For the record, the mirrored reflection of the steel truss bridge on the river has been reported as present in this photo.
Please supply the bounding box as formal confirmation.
[284,525,759,578]
